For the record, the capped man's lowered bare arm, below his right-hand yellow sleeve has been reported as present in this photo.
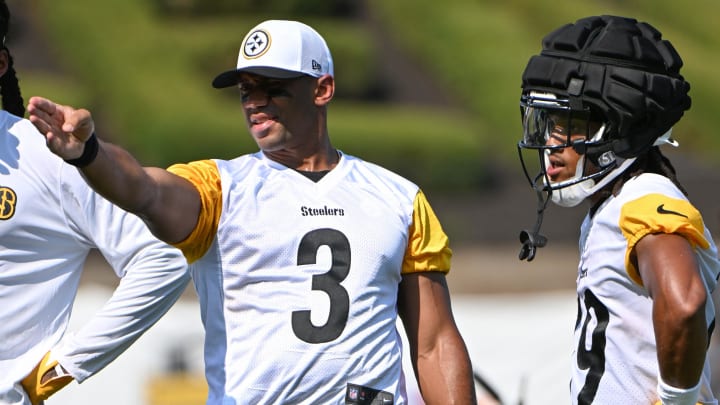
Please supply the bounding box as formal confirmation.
[398,272,476,405]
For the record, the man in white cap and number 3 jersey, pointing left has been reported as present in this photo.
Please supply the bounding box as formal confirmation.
[28,21,475,404]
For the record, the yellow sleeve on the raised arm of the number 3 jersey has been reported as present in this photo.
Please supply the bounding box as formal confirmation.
[168,160,222,263]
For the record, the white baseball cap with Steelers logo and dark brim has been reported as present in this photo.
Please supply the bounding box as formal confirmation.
[212,20,334,89]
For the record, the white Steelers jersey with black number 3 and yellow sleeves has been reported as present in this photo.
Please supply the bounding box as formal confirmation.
[171,152,451,404]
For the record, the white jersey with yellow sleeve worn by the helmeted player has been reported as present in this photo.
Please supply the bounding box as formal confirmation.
[570,173,720,404]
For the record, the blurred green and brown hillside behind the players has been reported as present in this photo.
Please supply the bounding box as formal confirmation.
[7,0,720,243]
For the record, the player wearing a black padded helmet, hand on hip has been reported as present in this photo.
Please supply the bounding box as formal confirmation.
[519,16,720,405]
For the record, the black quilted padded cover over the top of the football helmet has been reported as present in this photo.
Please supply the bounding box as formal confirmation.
[522,15,691,158]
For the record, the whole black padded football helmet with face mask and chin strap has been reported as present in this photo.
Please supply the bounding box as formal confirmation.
[518,15,690,260]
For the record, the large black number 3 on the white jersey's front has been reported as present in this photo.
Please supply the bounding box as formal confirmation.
[292,228,350,343]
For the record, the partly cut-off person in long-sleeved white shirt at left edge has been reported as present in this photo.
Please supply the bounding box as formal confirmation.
[0,0,189,405]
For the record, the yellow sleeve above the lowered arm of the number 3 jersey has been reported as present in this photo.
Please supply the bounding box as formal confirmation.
[402,190,452,274]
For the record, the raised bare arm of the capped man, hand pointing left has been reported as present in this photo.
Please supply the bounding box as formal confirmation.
[27,97,200,243]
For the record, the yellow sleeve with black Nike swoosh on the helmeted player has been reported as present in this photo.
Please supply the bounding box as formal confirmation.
[619,194,710,285]
